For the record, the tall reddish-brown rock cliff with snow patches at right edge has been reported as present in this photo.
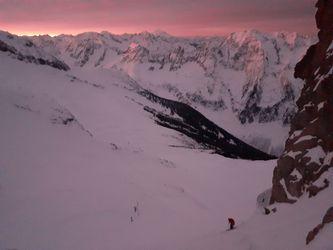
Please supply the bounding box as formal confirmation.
[271,0,333,203]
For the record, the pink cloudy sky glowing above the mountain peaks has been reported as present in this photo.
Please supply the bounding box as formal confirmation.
[0,0,317,36]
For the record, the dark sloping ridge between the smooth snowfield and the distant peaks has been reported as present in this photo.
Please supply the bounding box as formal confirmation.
[139,90,275,160]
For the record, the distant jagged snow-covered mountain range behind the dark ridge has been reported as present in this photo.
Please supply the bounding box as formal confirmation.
[26,30,315,155]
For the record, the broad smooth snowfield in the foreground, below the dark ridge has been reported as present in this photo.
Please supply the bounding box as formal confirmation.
[0,39,333,250]
